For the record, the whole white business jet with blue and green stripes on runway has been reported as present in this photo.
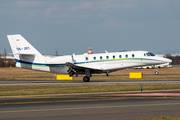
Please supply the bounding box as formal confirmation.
[7,34,172,82]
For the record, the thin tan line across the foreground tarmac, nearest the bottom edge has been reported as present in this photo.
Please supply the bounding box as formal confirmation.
[0,103,180,113]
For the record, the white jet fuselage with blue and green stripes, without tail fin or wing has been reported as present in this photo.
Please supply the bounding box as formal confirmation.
[16,51,171,74]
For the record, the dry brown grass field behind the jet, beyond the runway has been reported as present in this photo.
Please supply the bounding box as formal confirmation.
[0,66,180,81]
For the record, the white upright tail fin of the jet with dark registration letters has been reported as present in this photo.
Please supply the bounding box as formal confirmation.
[7,34,45,65]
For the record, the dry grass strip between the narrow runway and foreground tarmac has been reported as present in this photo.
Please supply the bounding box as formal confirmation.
[0,84,180,96]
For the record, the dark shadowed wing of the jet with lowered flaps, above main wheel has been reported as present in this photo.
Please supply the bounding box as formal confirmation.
[66,62,104,76]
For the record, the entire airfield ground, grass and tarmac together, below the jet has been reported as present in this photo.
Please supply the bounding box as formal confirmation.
[0,67,180,120]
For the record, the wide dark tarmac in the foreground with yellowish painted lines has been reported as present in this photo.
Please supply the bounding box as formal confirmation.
[0,91,180,120]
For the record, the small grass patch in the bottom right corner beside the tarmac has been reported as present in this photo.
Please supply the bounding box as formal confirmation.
[135,116,180,120]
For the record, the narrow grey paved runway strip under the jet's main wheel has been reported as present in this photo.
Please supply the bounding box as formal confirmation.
[0,80,180,86]
